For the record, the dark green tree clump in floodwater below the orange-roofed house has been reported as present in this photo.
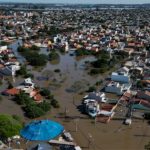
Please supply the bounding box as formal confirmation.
[14,89,59,118]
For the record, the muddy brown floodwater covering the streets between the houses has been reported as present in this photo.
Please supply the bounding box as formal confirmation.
[0,40,150,150]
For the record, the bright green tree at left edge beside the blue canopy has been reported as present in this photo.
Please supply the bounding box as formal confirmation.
[0,114,23,139]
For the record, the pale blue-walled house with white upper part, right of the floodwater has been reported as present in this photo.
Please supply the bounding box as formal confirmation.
[111,67,130,83]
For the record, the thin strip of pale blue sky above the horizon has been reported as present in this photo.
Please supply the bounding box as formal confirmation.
[0,0,150,4]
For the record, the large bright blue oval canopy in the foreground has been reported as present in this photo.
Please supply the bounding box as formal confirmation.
[20,120,64,141]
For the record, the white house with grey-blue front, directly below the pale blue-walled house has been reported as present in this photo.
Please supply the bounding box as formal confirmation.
[105,81,131,95]
